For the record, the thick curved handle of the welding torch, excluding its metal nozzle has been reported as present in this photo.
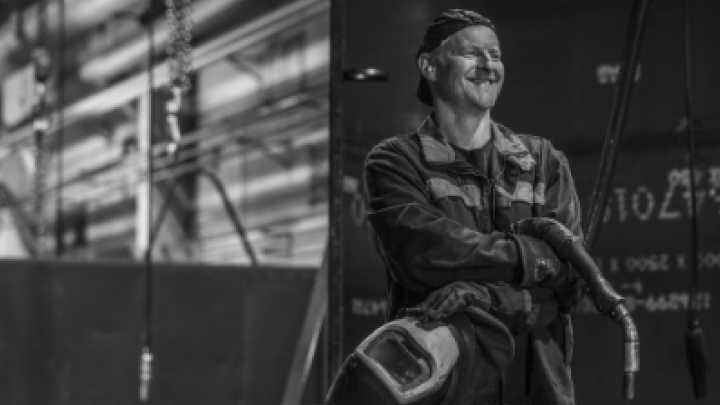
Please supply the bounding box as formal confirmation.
[510,218,624,315]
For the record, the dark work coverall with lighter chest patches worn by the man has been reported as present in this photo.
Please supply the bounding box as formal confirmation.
[365,115,581,405]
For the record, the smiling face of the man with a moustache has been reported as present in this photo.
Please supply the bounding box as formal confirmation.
[435,25,505,111]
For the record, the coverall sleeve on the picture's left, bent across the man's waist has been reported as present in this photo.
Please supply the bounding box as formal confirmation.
[365,141,524,294]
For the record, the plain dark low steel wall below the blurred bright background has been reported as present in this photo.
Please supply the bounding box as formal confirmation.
[0,261,322,405]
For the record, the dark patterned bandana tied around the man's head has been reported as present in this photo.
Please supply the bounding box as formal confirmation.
[415,9,495,107]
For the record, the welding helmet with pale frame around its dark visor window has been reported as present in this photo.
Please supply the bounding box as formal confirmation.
[327,314,475,405]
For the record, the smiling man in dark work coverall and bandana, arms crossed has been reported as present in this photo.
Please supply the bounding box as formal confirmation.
[365,10,582,405]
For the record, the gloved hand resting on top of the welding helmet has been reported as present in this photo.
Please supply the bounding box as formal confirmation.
[405,281,492,322]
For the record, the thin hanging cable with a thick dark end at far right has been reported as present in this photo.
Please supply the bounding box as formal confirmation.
[684,0,707,400]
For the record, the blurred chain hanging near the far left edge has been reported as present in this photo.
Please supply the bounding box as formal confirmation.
[32,0,50,256]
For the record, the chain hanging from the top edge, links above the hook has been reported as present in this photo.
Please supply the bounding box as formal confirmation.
[165,0,194,93]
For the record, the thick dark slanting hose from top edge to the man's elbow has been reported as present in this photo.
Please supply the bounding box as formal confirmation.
[585,0,650,251]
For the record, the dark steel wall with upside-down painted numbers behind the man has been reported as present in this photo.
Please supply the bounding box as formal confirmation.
[333,0,720,405]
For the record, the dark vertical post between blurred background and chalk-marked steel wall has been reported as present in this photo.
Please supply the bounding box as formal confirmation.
[327,0,345,381]
